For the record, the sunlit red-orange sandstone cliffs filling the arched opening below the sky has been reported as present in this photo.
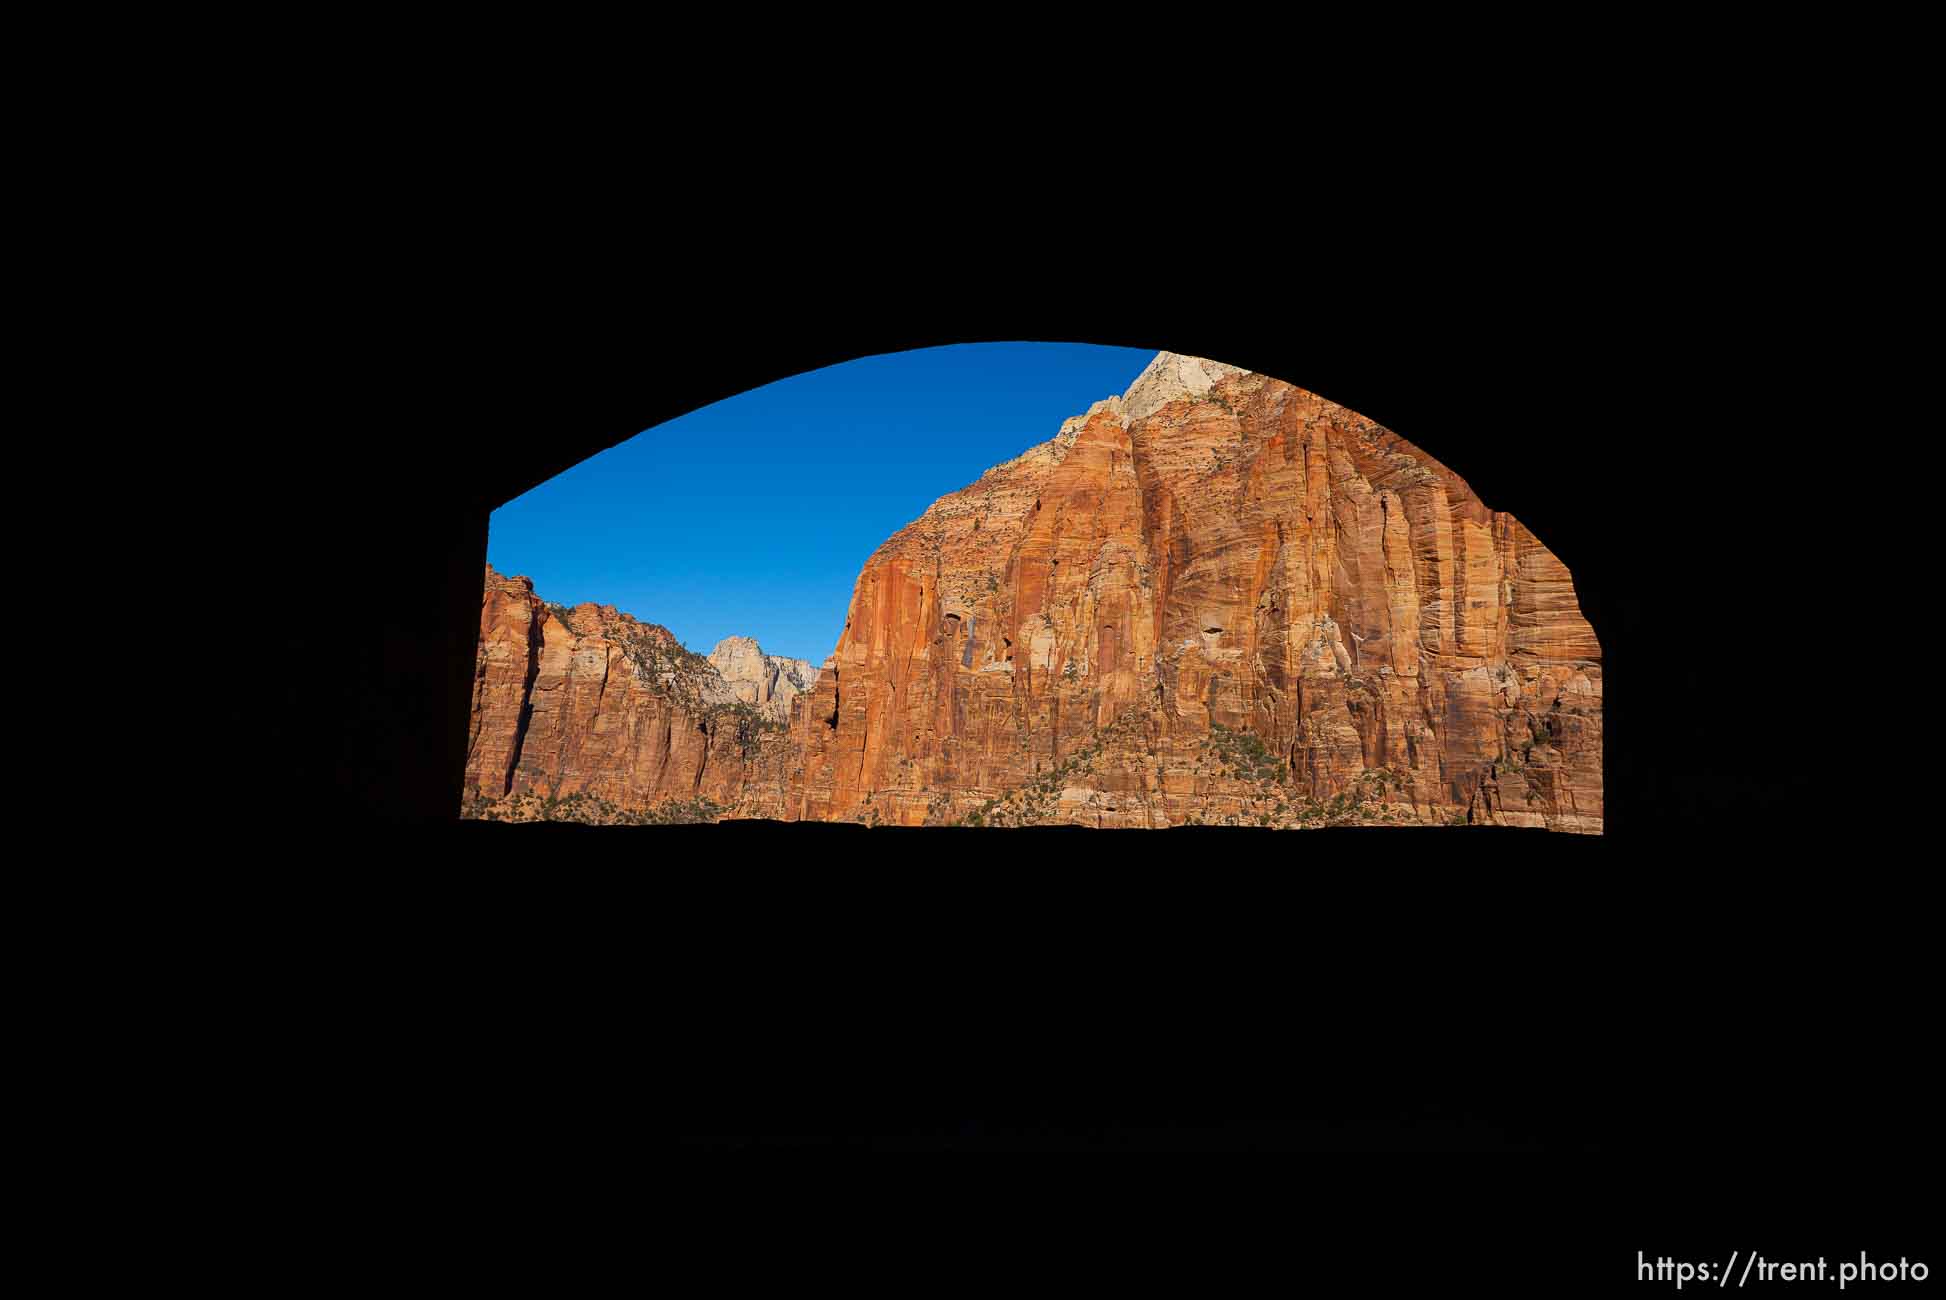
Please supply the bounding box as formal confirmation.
[467,352,1602,833]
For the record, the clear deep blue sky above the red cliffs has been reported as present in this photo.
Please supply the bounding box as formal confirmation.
[487,343,1154,664]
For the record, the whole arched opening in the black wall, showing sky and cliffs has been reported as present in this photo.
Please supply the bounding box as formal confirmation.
[463,344,1604,833]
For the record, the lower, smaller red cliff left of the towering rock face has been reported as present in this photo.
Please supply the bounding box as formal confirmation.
[465,566,780,810]
